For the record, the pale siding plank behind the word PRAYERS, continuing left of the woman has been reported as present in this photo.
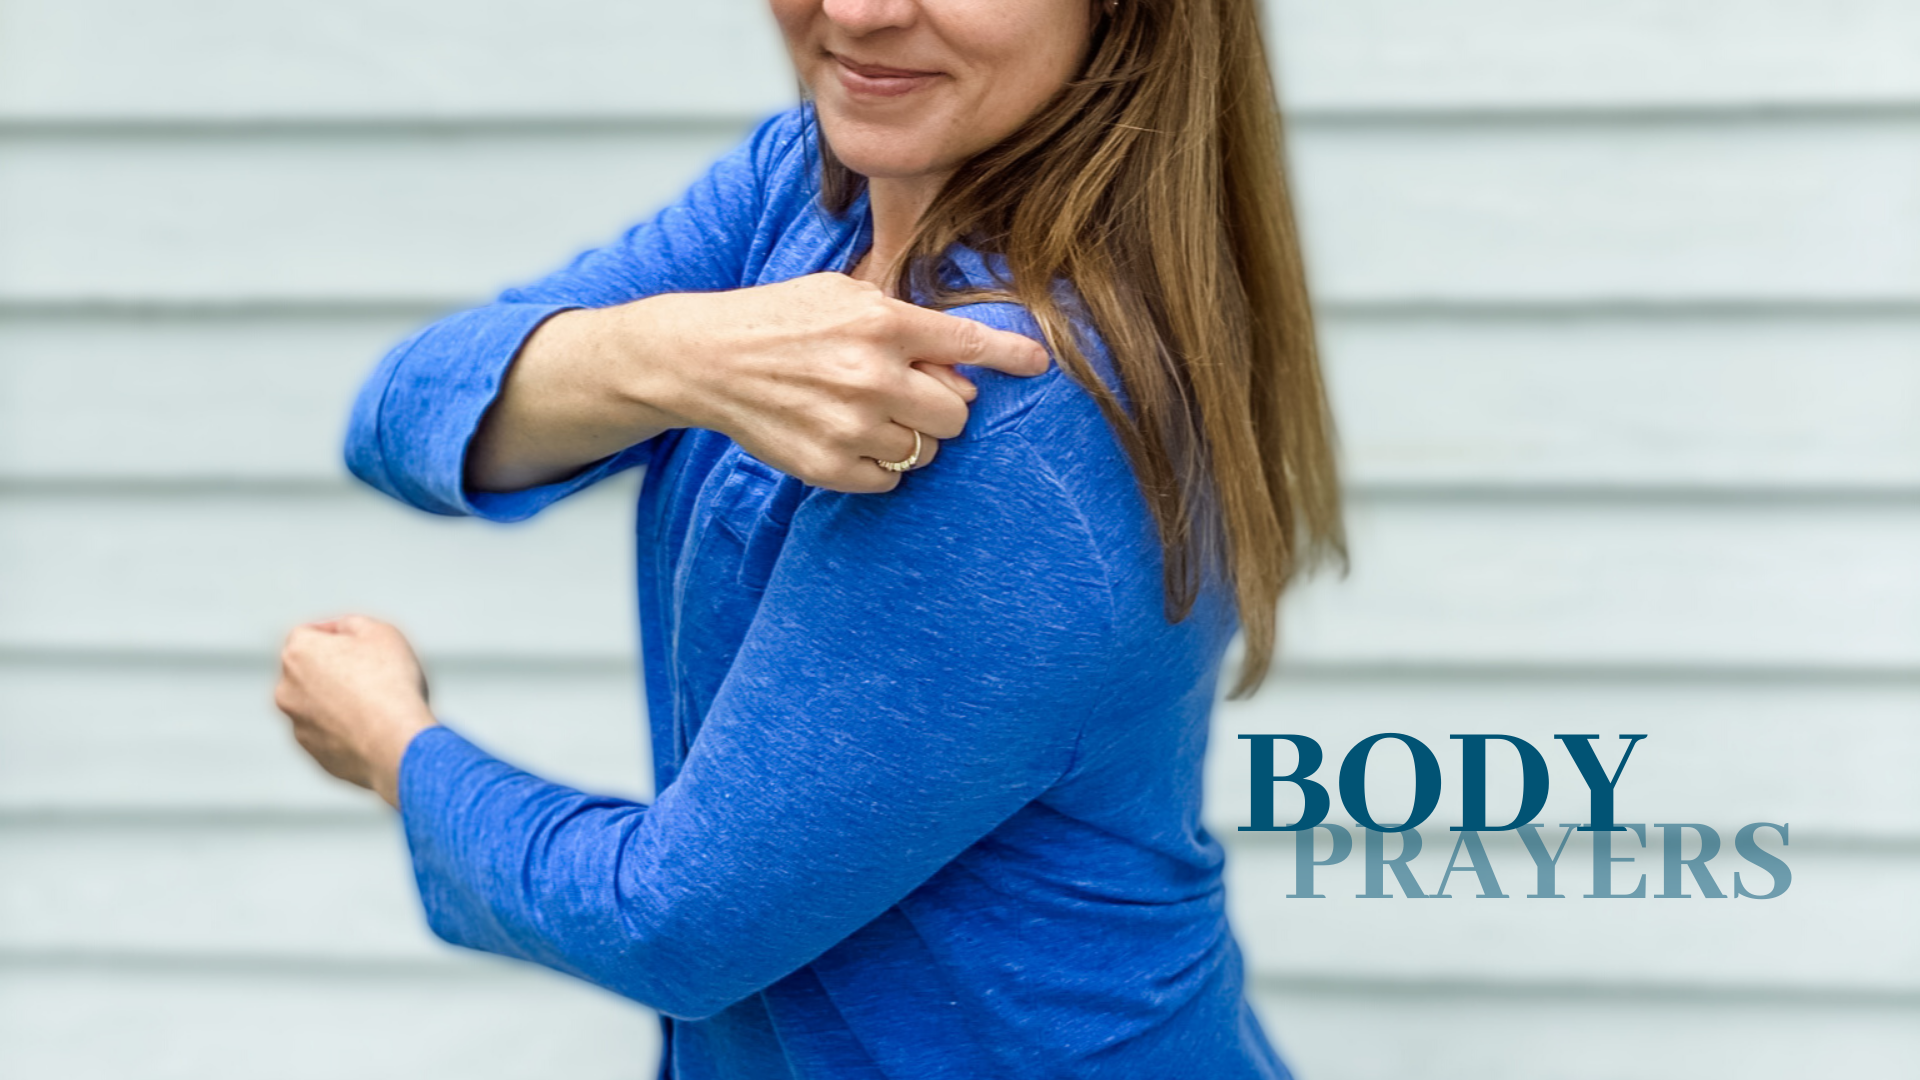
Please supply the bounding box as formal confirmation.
[0,821,1920,992]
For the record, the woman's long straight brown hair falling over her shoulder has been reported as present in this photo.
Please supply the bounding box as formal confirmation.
[820,0,1346,698]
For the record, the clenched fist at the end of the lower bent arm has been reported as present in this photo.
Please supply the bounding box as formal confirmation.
[273,615,436,809]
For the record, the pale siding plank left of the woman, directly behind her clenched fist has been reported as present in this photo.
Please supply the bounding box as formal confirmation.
[0,661,653,815]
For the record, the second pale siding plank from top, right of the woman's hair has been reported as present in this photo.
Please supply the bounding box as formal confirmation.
[1294,119,1920,304]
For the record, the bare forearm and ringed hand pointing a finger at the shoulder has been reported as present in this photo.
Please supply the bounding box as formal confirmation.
[467,273,1048,492]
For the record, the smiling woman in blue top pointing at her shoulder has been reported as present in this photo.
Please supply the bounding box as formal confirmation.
[278,0,1340,1080]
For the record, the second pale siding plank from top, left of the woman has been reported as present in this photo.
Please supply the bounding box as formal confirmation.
[0,125,745,302]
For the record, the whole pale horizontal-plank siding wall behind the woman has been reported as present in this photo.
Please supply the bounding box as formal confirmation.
[0,0,1920,1080]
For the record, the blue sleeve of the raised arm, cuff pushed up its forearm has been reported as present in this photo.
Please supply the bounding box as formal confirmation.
[346,113,803,521]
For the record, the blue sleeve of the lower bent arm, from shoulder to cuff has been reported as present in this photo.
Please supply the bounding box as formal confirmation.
[401,420,1114,1019]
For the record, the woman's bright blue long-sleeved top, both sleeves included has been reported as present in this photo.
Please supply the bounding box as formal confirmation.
[348,110,1286,1080]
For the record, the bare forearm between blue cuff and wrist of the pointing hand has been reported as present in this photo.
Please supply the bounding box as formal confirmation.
[467,296,687,492]
